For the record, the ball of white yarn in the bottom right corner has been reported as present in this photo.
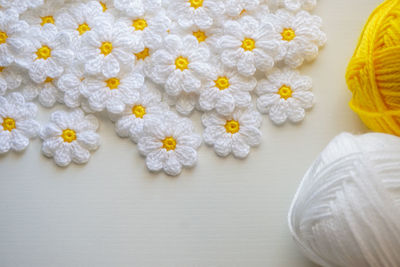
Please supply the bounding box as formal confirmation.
[289,133,400,267]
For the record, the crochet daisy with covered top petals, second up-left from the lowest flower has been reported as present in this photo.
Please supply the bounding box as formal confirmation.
[81,69,144,114]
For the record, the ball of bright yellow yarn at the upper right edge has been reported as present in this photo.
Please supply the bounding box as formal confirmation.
[346,0,400,136]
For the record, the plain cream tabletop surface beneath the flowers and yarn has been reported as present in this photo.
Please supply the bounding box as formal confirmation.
[0,0,381,267]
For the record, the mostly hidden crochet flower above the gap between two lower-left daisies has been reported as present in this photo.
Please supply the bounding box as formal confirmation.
[22,77,63,108]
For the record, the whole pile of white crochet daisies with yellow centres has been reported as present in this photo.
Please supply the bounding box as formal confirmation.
[0,0,326,175]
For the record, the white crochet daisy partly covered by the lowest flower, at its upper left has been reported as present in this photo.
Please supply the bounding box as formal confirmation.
[115,82,168,143]
